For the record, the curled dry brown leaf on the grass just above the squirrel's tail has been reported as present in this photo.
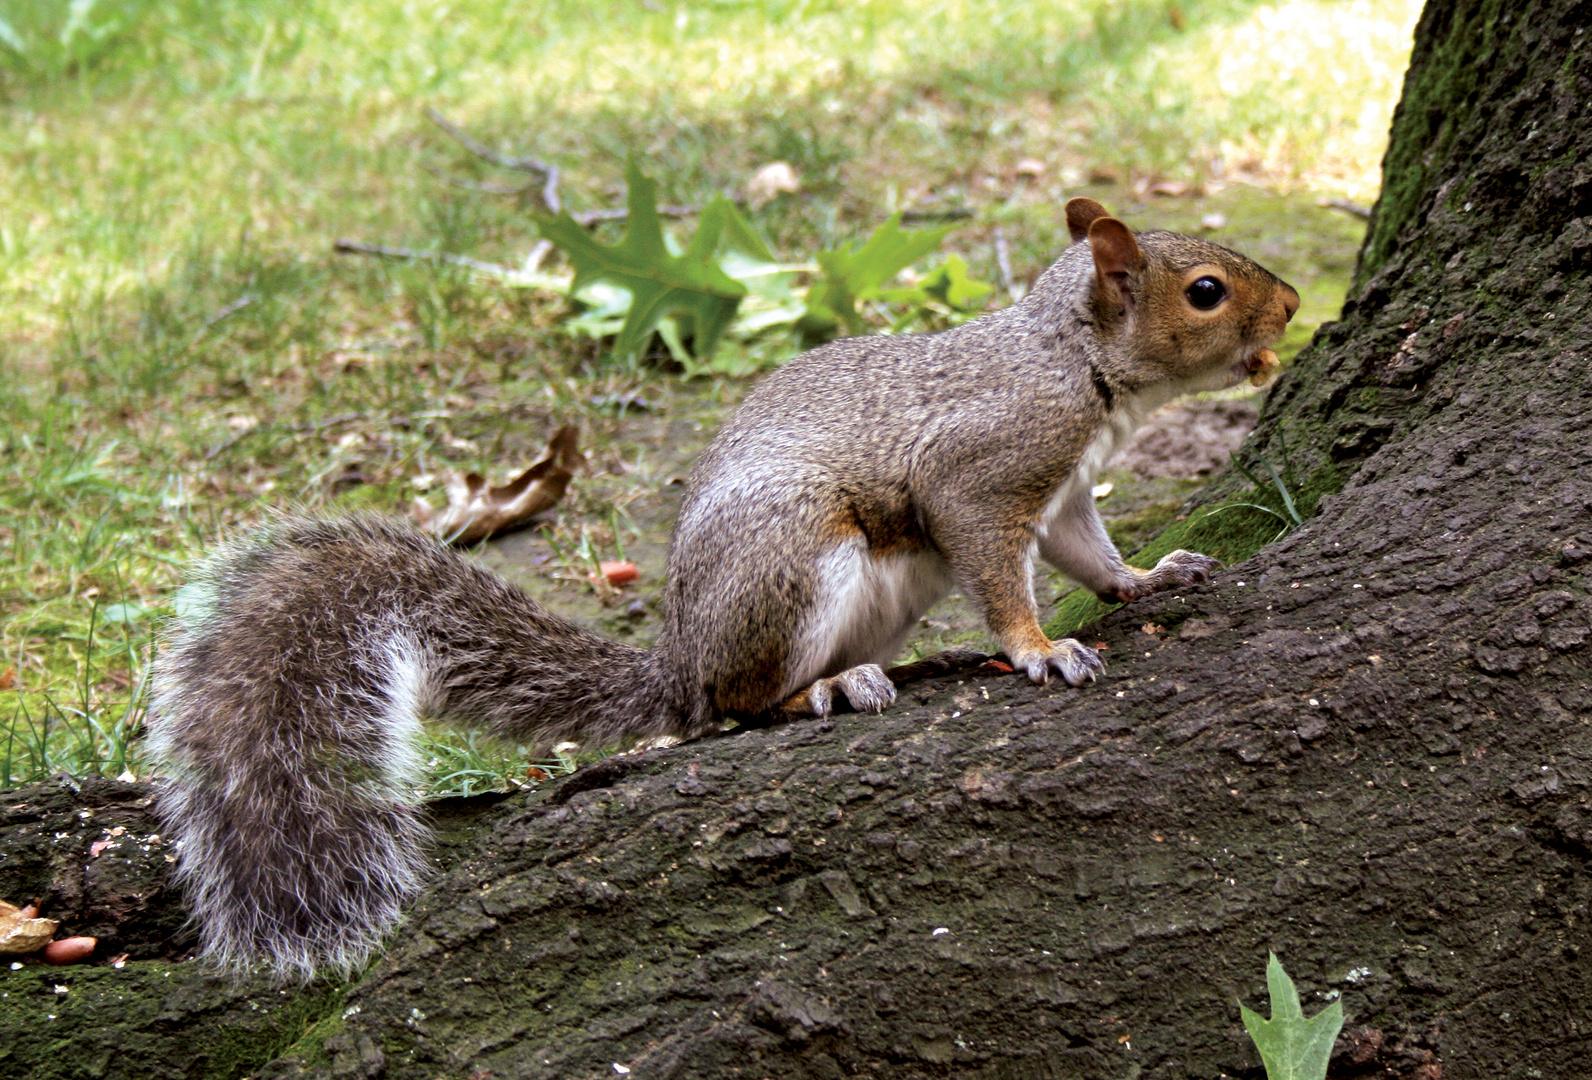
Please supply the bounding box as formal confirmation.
[414,424,586,543]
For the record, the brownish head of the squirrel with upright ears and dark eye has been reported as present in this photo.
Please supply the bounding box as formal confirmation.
[1067,199,1299,390]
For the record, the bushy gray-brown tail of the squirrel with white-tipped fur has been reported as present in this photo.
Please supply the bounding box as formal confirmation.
[150,518,699,978]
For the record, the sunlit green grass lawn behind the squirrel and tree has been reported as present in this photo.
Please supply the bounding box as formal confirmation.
[0,0,1417,790]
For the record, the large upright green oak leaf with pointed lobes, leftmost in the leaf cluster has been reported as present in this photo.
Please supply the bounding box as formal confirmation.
[537,161,745,360]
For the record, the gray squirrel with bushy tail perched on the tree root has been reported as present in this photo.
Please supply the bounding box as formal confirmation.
[148,199,1299,978]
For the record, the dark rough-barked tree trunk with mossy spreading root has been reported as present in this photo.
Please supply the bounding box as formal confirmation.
[0,0,1592,1080]
